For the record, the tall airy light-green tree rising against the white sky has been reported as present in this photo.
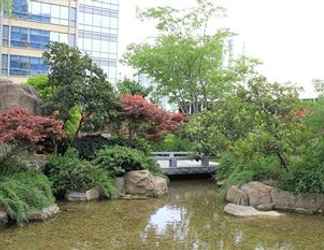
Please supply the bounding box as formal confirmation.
[124,1,256,113]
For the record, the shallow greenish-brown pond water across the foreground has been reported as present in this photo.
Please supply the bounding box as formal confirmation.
[0,179,324,250]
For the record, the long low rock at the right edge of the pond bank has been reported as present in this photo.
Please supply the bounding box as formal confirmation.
[271,188,324,214]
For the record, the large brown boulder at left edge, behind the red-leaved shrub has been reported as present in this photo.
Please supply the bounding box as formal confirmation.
[0,79,41,114]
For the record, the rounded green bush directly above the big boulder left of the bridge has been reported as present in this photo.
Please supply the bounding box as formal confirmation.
[94,146,160,176]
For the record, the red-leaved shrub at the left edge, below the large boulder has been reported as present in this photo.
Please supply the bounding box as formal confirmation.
[0,107,64,145]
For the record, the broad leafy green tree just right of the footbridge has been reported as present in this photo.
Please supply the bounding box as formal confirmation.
[186,76,308,172]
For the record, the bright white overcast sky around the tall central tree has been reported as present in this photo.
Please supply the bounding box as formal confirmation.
[119,0,324,97]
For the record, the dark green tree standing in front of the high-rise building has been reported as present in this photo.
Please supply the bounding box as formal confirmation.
[44,43,118,135]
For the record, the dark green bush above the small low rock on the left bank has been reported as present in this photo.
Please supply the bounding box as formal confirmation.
[45,148,114,197]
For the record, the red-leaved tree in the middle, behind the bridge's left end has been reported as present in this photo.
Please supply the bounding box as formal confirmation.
[121,95,185,138]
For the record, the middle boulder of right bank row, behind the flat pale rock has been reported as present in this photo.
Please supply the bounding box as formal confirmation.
[240,181,272,207]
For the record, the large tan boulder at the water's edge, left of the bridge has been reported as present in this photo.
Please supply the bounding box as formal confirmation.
[125,170,168,197]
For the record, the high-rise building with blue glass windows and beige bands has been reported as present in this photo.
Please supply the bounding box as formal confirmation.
[0,0,119,83]
